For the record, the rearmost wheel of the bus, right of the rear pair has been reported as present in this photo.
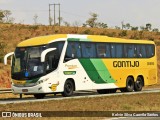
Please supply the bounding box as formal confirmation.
[134,77,143,91]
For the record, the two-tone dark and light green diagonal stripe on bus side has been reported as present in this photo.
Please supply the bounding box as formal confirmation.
[79,59,115,83]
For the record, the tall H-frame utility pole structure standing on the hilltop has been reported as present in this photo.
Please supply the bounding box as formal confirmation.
[49,3,61,26]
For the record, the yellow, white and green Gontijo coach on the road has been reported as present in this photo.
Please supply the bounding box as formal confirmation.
[4,34,157,98]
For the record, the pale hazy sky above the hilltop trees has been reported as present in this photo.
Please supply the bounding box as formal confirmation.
[0,0,160,29]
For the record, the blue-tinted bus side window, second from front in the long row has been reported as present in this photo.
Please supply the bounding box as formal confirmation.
[81,42,96,58]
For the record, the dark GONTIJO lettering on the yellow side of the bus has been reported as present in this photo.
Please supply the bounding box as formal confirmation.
[113,61,139,67]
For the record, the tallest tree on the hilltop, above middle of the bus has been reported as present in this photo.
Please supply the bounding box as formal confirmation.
[86,13,98,28]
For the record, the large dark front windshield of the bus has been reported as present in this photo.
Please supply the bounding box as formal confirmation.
[12,46,46,79]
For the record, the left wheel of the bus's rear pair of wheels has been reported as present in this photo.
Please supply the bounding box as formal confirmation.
[126,77,134,92]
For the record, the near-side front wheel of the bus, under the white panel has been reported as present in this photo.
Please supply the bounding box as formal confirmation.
[62,80,74,97]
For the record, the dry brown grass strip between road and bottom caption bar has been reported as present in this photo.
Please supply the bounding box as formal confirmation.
[0,93,160,111]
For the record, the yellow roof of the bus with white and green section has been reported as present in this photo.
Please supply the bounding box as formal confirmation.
[18,34,154,47]
